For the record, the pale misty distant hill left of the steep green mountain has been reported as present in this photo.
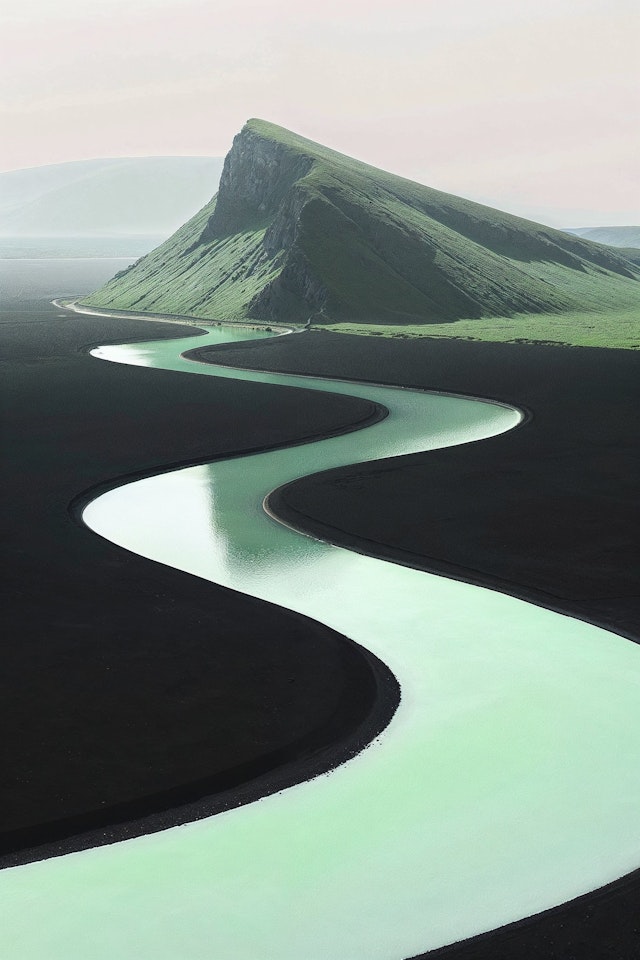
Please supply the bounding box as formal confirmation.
[0,157,222,238]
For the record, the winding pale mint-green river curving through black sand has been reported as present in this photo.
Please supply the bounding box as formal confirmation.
[0,329,640,960]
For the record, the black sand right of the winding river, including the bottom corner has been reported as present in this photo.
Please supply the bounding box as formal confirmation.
[194,331,640,960]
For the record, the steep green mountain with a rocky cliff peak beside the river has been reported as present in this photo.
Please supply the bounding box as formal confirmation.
[88,120,640,324]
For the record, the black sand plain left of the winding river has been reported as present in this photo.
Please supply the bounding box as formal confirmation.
[0,302,398,864]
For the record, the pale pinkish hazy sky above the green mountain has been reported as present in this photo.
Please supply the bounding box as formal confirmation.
[0,0,640,226]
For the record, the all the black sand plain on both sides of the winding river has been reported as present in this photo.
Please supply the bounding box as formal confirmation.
[2,284,640,960]
